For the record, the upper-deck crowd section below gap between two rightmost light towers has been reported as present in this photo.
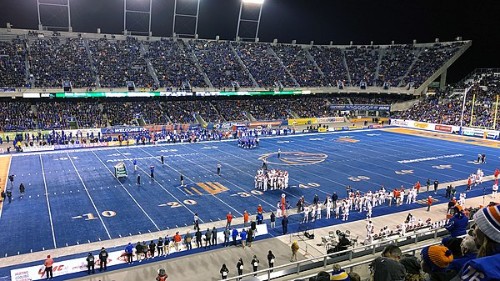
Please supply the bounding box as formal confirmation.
[189,40,253,89]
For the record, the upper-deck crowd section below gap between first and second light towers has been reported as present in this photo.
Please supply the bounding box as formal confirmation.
[89,37,154,88]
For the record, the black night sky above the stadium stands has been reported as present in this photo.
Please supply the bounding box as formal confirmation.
[0,0,500,82]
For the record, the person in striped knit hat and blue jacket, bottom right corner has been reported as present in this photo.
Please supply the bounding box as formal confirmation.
[459,205,500,281]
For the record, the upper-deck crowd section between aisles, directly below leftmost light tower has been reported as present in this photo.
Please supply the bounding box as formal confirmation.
[28,37,96,88]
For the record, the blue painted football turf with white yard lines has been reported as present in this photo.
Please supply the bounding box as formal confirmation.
[0,130,500,256]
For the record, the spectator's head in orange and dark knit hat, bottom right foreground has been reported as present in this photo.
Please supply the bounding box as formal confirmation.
[421,245,457,281]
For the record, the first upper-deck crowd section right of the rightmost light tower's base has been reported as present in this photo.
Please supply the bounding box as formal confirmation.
[273,44,325,87]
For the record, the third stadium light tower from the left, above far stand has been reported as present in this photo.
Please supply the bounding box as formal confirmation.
[172,0,200,38]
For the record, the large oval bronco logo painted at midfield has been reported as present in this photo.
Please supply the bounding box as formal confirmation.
[259,152,328,165]
